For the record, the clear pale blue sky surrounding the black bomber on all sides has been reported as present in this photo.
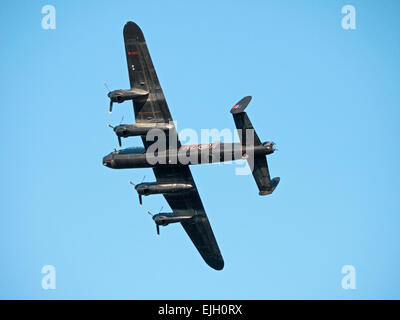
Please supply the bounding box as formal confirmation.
[0,0,400,299]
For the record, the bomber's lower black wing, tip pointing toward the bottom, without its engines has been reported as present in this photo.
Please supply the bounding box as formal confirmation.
[153,166,224,270]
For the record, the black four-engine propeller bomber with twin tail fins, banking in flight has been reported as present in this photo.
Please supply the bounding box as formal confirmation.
[102,22,280,270]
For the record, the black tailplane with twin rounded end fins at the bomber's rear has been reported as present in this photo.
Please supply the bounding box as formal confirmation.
[231,96,280,196]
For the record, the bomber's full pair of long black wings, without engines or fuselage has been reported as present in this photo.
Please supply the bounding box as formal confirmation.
[124,22,224,270]
